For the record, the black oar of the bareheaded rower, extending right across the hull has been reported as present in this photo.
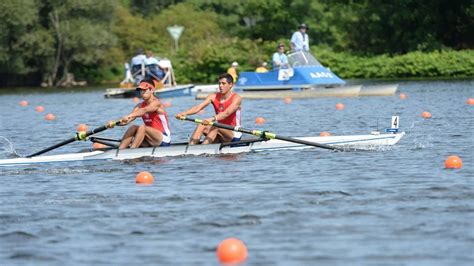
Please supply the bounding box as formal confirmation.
[176,116,344,151]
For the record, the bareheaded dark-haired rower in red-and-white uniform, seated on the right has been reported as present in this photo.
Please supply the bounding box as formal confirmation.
[176,73,242,144]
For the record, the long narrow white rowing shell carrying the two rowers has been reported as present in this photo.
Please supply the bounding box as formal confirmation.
[0,132,405,166]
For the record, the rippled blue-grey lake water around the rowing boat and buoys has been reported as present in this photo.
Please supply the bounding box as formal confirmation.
[0,80,474,265]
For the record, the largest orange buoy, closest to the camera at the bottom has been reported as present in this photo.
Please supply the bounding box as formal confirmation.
[216,238,248,263]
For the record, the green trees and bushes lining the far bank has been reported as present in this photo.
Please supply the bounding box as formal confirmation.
[0,0,474,86]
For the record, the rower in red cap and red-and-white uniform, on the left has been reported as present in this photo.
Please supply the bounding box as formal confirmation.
[119,79,171,149]
